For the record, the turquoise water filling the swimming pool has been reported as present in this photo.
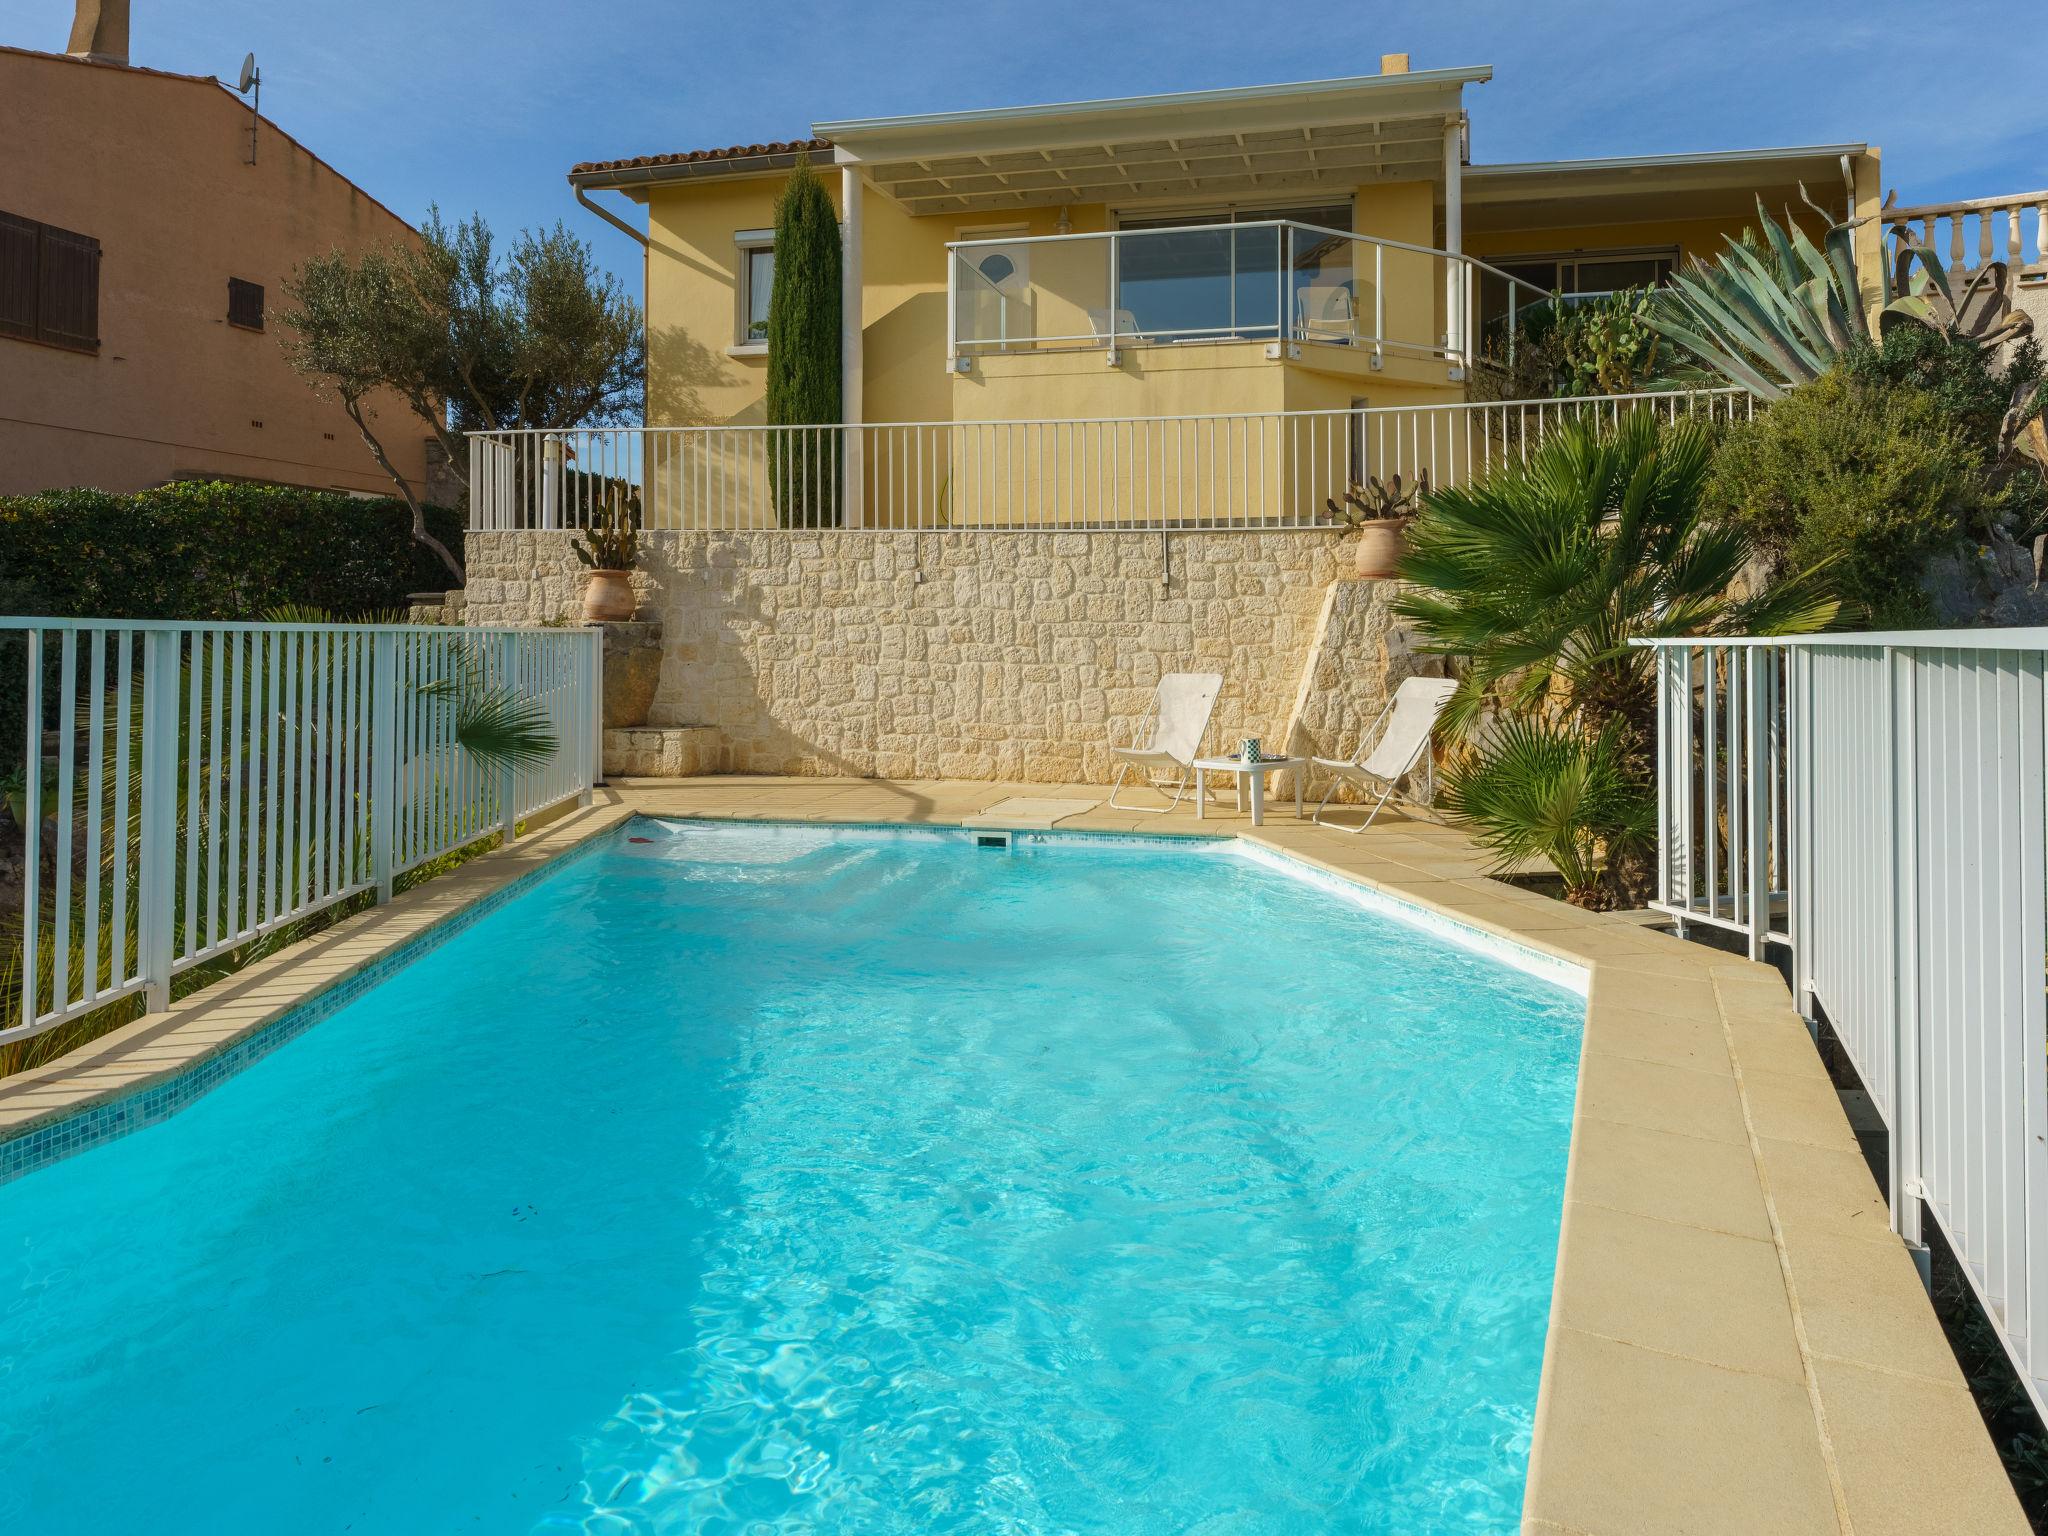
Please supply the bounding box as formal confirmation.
[0,823,1583,1536]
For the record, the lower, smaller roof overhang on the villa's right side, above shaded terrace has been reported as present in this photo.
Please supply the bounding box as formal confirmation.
[1462,143,1870,233]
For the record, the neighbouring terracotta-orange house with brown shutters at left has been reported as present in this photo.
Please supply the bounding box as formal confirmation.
[0,0,428,496]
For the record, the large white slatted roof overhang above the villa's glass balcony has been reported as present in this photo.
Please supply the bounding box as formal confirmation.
[813,68,1493,213]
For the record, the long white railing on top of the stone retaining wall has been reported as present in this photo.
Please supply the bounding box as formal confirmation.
[469,389,1755,532]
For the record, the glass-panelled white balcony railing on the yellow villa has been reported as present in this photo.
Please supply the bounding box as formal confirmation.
[946,219,1548,365]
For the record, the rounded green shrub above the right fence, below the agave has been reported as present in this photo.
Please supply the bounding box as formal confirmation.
[1704,367,2005,627]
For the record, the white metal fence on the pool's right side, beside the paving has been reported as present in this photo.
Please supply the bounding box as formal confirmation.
[1647,629,2048,1413]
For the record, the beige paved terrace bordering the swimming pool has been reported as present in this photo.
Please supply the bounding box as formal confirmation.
[0,776,2028,1536]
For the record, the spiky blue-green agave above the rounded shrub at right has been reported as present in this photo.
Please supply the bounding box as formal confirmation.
[1649,186,2034,399]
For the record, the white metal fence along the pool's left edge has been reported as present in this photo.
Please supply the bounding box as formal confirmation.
[0,618,600,1042]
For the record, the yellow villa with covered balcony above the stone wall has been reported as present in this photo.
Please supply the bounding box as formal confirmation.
[503,55,1880,526]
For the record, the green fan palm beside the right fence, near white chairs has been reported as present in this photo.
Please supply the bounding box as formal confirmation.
[1395,412,1837,903]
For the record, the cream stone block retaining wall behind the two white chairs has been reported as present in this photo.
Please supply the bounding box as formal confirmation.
[467,532,1436,784]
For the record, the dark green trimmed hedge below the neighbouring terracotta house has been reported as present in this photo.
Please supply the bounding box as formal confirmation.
[0,481,463,618]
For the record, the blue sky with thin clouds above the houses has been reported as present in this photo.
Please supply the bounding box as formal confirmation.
[0,0,2048,289]
